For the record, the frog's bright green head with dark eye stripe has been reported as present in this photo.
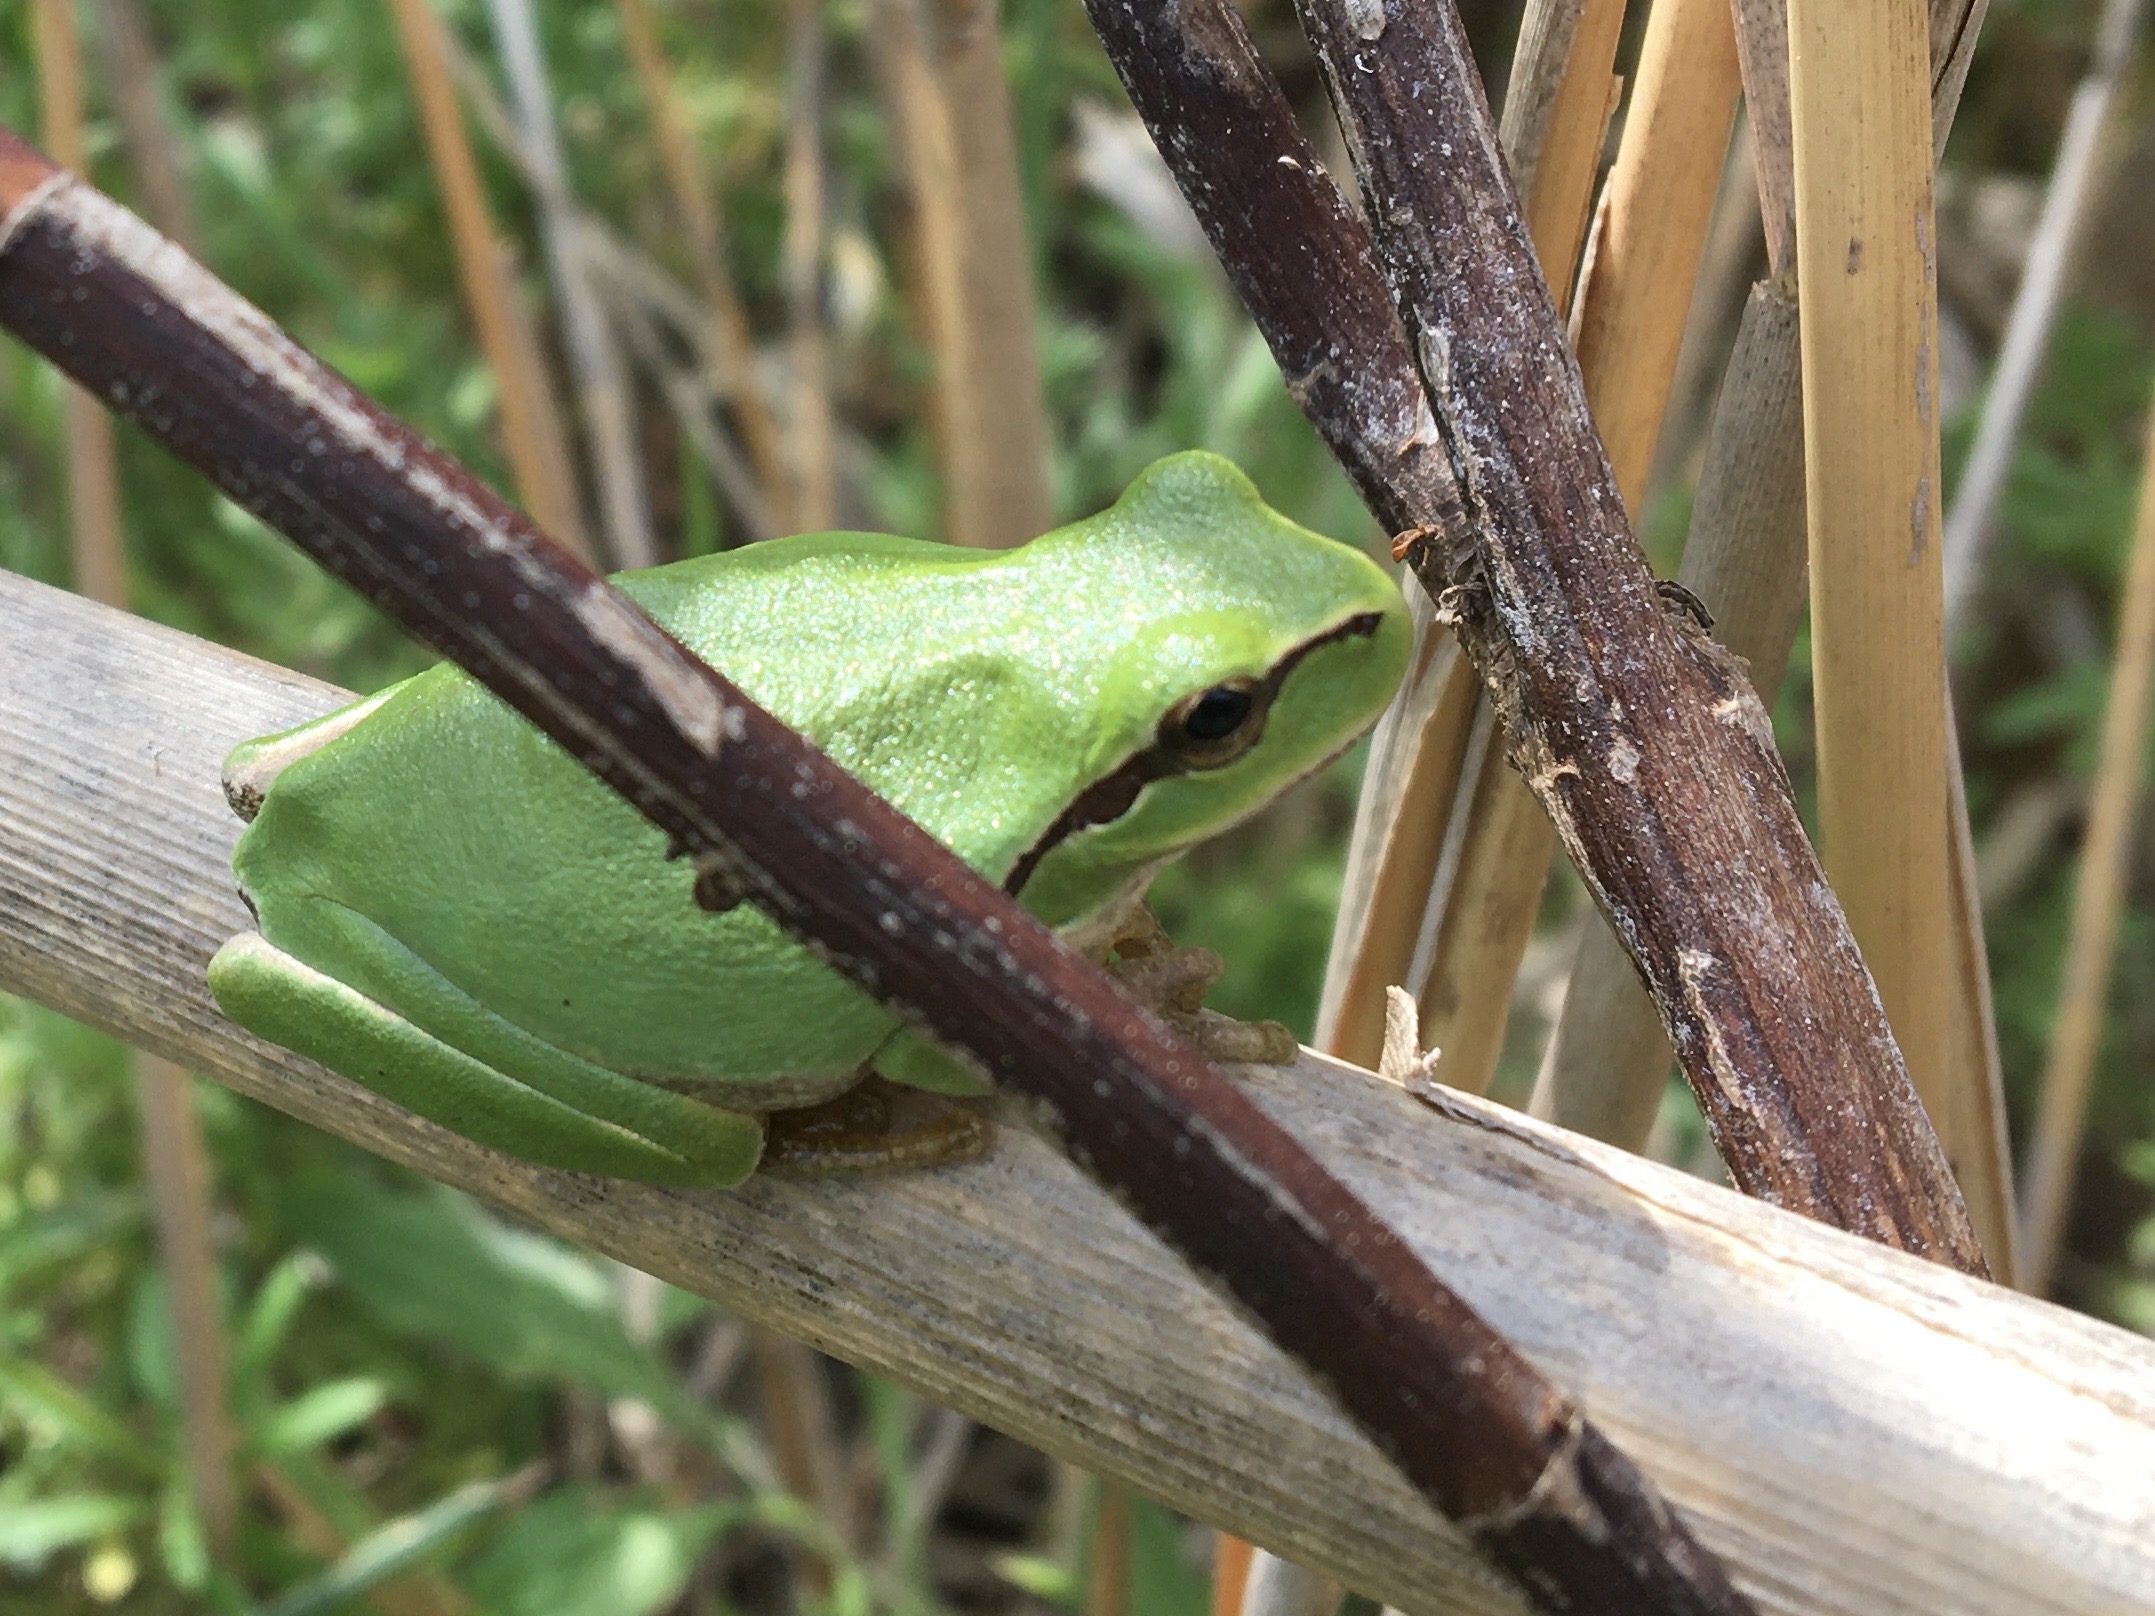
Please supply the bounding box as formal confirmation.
[1006,452,1412,924]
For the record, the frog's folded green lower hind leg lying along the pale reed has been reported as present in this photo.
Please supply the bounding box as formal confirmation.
[209,931,763,1185]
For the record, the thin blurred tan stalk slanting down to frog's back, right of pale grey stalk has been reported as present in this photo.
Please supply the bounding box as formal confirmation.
[614,0,789,511]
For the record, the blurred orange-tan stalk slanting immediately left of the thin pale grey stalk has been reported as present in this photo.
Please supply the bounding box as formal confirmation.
[390,0,590,556]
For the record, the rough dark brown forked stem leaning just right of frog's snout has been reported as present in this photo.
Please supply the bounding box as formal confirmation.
[1088,0,1985,1273]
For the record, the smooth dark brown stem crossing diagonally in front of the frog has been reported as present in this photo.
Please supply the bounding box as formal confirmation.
[0,134,1750,1614]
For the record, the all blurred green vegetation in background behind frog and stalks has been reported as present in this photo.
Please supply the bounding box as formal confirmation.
[0,0,2155,1616]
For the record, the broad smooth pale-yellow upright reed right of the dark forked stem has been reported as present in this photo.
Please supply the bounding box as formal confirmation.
[1789,0,1961,1180]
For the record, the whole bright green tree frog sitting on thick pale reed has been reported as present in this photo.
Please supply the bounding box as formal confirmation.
[209,452,1409,1185]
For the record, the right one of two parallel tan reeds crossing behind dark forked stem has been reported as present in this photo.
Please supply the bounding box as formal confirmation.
[1420,0,1741,1092]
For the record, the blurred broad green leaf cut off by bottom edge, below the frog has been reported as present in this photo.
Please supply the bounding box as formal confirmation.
[465,1487,737,1616]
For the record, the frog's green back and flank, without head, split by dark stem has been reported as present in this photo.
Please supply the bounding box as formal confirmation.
[235,534,1077,1103]
